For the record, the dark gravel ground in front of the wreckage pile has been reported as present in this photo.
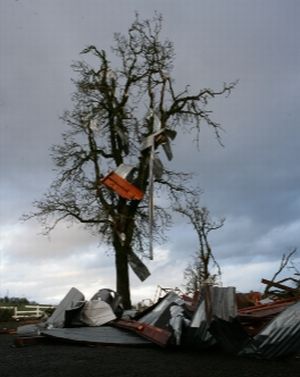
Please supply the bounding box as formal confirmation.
[0,334,300,377]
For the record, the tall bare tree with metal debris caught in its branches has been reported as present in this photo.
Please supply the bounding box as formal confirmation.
[25,14,236,307]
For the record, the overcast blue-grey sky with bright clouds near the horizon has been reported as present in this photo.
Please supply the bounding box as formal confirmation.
[0,0,300,303]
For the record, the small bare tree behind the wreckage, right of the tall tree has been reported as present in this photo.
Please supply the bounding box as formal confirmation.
[177,199,225,293]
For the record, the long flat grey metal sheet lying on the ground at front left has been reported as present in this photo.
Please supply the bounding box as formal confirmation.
[41,326,152,346]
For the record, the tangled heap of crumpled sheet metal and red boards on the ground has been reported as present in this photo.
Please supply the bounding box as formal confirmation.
[15,282,300,359]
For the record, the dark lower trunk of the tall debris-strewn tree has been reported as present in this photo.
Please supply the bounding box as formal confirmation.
[114,240,131,309]
